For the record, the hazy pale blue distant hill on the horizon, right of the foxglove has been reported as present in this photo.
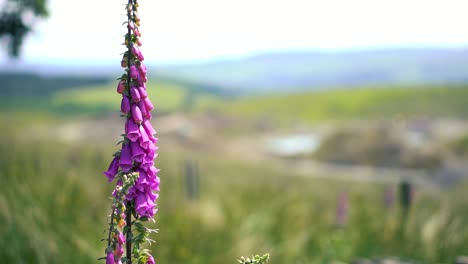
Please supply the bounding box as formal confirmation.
[158,49,468,93]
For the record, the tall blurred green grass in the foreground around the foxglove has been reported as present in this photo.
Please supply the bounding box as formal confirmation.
[0,123,468,264]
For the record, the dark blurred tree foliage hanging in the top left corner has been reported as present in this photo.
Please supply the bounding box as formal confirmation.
[0,0,49,57]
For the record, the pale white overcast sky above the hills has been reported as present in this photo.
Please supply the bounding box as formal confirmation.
[2,0,468,64]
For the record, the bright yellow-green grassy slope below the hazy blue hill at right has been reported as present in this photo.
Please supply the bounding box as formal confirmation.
[198,86,468,123]
